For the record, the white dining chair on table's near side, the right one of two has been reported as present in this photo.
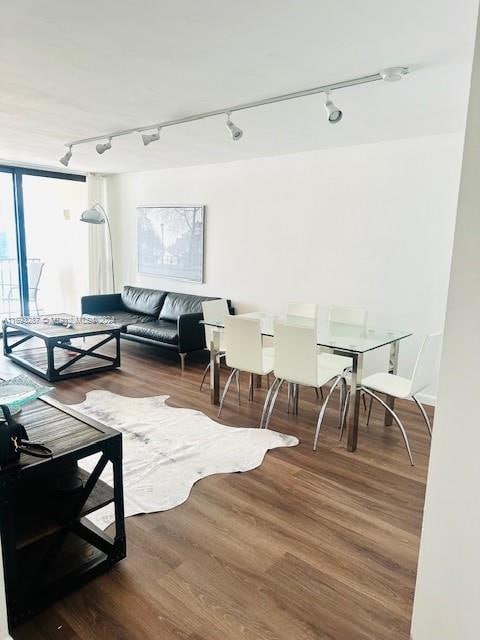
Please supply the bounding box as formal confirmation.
[260,321,346,449]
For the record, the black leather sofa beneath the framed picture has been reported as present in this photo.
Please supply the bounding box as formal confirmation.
[81,286,230,369]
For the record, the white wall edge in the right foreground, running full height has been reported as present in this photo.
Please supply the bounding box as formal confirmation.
[412,6,480,640]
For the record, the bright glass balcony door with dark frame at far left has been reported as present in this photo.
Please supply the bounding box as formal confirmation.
[0,166,88,317]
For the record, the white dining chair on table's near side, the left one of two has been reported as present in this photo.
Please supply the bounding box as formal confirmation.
[218,315,274,417]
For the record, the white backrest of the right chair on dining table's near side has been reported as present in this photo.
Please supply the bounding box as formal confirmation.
[273,321,318,387]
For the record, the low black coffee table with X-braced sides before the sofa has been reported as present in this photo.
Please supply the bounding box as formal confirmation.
[2,314,120,382]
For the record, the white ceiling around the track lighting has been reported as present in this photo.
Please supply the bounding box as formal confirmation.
[0,0,478,172]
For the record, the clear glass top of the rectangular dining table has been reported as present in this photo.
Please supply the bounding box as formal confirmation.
[202,311,412,353]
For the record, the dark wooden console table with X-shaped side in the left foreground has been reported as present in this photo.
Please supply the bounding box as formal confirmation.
[0,398,126,626]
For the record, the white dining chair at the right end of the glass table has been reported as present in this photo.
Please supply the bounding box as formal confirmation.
[352,332,442,466]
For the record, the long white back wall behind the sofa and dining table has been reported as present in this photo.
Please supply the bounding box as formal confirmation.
[108,134,462,402]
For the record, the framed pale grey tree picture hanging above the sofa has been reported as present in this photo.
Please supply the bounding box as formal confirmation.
[137,205,205,282]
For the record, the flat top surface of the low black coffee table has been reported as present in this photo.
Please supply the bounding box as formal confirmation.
[3,313,120,339]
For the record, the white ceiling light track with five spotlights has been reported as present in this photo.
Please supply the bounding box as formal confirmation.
[60,67,409,166]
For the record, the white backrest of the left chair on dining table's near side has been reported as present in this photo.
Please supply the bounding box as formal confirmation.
[224,315,263,375]
